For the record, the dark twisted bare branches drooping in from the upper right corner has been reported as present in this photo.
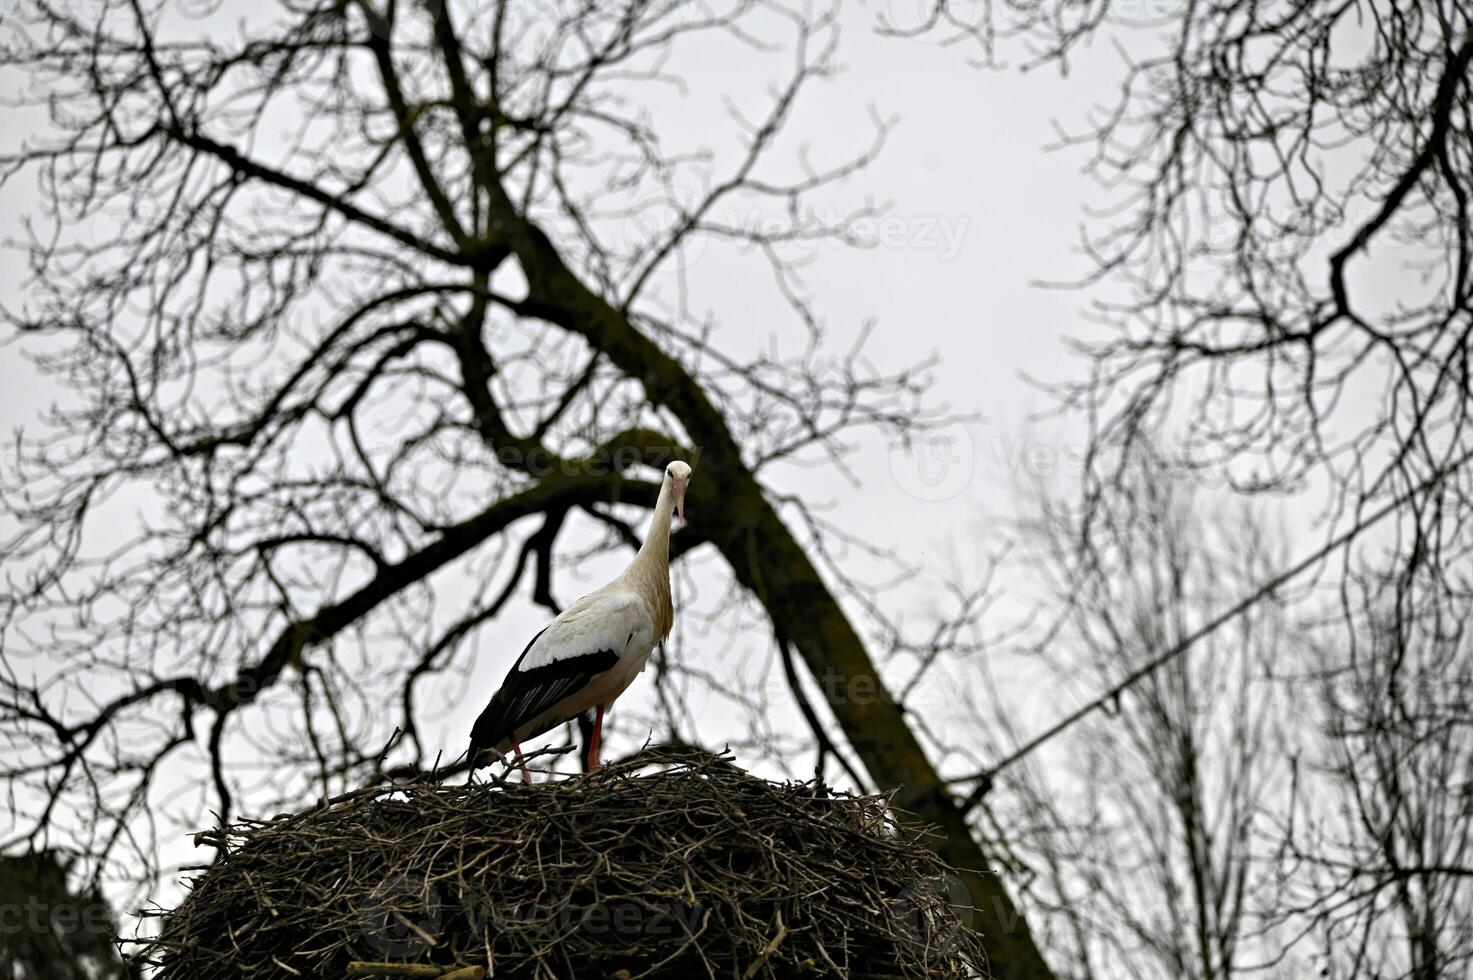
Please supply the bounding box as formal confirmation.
[891,0,1473,601]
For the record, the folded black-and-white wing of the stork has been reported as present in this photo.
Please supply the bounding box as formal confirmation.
[470,591,650,765]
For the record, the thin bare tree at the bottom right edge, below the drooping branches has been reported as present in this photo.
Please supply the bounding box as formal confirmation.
[1279,573,1473,980]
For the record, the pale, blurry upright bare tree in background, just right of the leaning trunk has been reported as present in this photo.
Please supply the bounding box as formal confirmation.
[985,447,1295,980]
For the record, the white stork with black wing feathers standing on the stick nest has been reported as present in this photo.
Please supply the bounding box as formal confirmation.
[467,460,691,781]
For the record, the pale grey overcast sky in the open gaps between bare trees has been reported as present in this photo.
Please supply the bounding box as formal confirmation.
[0,0,1266,901]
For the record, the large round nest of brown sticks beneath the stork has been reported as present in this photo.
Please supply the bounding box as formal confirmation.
[150,752,984,980]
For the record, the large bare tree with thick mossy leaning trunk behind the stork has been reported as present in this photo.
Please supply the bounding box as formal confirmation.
[0,0,1050,979]
